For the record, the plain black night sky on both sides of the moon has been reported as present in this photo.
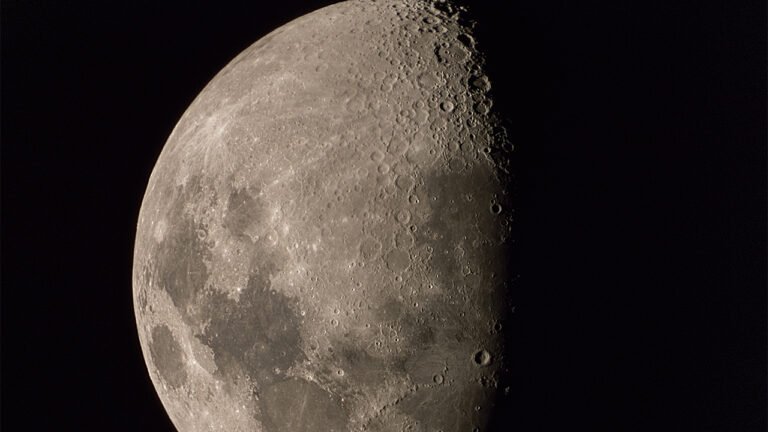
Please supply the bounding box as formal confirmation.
[0,0,768,432]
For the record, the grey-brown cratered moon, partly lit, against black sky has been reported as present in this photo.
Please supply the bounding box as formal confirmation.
[133,0,513,432]
